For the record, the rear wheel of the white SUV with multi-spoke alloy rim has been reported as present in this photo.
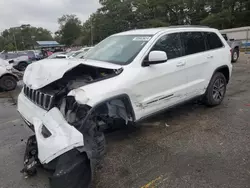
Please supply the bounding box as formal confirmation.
[205,72,227,107]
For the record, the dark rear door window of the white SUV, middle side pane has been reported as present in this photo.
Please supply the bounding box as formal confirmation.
[181,32,206,55]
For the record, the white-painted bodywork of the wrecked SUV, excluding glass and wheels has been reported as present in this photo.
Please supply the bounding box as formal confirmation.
[18,27,232,163]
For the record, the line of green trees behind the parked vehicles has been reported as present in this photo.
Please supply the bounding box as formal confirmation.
[0,0,250,49]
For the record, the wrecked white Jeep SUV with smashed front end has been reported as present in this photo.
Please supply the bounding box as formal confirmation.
[18,26,232,188]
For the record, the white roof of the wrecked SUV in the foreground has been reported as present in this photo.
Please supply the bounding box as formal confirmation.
[115,25,216,35]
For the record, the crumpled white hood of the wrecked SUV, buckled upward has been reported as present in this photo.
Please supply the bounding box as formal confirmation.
[23,59,121,89]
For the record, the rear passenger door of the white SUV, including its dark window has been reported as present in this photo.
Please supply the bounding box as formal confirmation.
[181,31,212,98]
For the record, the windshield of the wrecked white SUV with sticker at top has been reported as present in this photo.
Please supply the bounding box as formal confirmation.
[85,35,152,65]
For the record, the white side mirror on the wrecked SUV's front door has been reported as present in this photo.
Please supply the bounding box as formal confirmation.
[143,51,168,66]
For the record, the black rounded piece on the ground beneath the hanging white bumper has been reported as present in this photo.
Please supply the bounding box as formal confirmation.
[50,149,92,188]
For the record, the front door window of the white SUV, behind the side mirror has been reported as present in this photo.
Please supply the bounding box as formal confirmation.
[151,33,182,59]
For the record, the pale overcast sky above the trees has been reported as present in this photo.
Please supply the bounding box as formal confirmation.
[0,0,100,33]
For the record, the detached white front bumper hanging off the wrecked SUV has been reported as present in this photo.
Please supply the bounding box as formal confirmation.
[17,92,84,164]
